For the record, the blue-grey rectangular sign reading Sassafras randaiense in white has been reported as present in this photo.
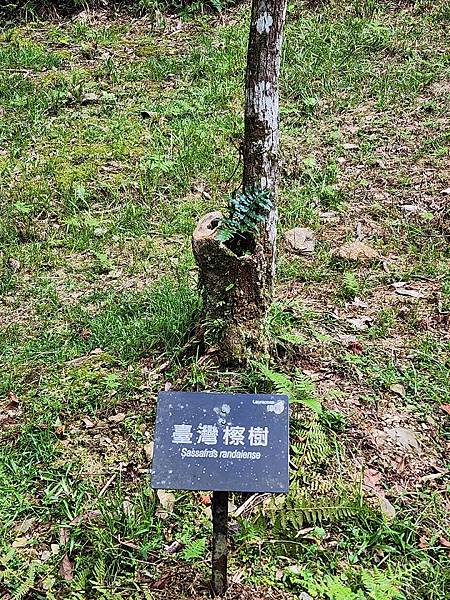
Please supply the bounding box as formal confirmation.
[152,392,289,493]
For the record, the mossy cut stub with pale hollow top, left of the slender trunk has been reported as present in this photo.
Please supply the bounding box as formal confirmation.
[192,212,269,364]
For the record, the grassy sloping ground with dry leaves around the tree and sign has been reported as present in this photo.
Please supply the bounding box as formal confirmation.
[0,0,450,600]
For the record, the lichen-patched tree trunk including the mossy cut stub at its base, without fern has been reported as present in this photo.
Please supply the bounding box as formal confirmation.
[193,0,287,363]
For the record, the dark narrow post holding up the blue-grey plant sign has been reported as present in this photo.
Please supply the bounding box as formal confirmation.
[212,492,228,596]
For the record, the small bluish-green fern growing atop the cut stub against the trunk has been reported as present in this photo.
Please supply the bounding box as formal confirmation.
[216,187,273,242]
